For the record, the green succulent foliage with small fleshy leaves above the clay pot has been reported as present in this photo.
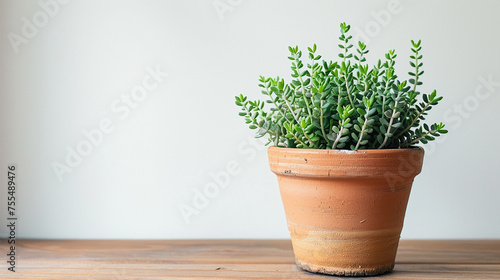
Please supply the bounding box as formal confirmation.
[236,23,447,150]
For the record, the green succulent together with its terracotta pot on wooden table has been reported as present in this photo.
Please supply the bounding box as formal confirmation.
[236,23,447,276]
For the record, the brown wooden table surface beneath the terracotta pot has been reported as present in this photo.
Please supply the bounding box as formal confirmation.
[0,240,500,279]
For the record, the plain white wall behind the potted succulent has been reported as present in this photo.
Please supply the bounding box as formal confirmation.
[0,0,500,239]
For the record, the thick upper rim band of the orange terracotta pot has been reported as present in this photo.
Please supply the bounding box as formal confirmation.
[268,146,424,178]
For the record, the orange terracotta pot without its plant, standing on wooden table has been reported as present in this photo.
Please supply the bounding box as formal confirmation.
[268,147,424,276]
